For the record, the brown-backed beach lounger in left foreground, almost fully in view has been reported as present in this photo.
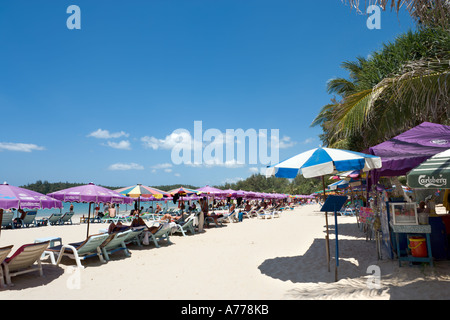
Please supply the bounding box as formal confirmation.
[2,241,49,286]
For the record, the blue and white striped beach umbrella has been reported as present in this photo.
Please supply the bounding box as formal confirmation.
[266,148,381,179]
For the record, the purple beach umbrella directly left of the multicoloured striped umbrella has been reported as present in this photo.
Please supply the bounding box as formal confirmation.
[48,183,134,204]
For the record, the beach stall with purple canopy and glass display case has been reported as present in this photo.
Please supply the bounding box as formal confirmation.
[368,122,450,262]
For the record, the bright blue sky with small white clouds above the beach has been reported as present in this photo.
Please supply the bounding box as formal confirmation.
[0,0,414,187]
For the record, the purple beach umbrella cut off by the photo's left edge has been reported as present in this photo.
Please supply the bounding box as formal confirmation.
[0,183,63,209]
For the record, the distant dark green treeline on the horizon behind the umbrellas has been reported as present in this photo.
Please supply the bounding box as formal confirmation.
[21,174,334,194]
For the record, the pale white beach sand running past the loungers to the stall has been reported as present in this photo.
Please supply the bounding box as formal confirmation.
[0,205,450,300]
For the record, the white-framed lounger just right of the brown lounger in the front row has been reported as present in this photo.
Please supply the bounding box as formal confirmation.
[45,233,109,268]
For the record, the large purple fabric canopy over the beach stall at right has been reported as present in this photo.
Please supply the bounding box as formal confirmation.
[369,122,450,181]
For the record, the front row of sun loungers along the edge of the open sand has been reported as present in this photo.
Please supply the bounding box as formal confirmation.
[0,208,288,287]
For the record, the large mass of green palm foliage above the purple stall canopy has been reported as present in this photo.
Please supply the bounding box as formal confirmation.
[312,28,450,151]
